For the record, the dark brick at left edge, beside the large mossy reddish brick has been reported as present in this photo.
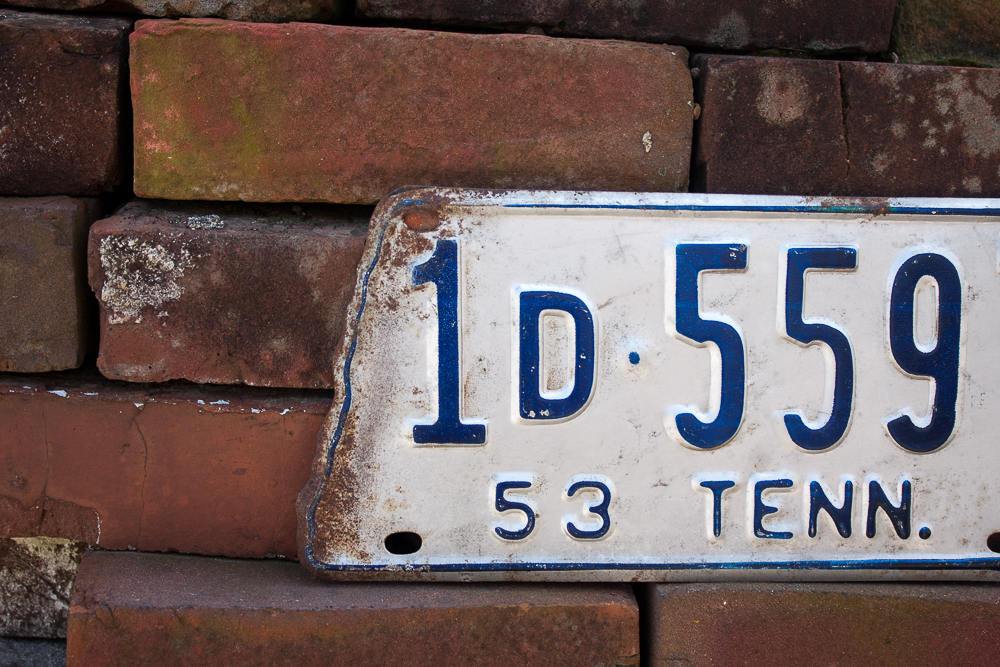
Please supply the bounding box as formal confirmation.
[0,9,130,195]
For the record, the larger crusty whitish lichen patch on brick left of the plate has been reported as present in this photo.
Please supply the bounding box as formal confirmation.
[100,236,192,324]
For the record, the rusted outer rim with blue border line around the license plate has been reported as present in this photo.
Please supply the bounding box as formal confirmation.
[298,188,1000,581]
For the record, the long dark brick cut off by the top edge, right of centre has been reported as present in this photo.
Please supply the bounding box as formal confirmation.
[358,0,896,52]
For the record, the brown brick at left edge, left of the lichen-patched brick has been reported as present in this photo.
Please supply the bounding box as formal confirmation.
[0,198,97,373]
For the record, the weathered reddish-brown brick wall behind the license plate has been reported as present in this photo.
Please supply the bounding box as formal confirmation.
[0,0,1000,665]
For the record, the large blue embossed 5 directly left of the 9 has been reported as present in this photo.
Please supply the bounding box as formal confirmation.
[785,248,858,452]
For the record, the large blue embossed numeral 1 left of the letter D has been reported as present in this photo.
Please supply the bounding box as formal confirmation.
[413,239,486,445]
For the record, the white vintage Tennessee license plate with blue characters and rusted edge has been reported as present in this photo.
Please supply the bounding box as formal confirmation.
[300,190,1000,580]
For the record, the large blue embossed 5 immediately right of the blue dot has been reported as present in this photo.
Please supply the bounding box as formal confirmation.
[675,243,747,449]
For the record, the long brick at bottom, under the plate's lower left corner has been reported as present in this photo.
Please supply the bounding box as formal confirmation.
[67,553,639,667]
